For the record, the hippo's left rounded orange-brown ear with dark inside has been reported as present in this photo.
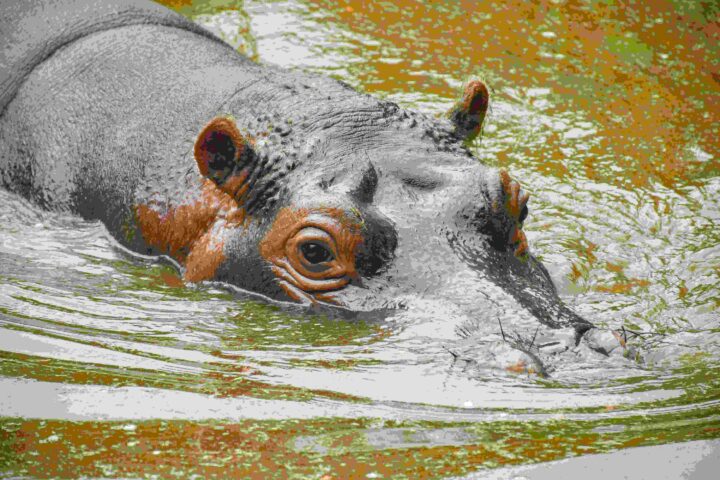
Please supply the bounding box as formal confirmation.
[195,117,250,185]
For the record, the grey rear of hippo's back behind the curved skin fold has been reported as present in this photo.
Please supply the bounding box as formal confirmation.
[0,0,219,115]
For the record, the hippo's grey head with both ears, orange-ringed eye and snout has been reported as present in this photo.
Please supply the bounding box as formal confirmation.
[136,77,590,366]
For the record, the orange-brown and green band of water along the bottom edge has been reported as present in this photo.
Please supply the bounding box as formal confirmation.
[0,410,720,478]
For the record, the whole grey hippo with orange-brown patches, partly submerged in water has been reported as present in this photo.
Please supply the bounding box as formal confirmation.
[0,0,622,374]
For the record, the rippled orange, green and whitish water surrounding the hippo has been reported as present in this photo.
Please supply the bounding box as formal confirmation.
[0,0,720,478]
